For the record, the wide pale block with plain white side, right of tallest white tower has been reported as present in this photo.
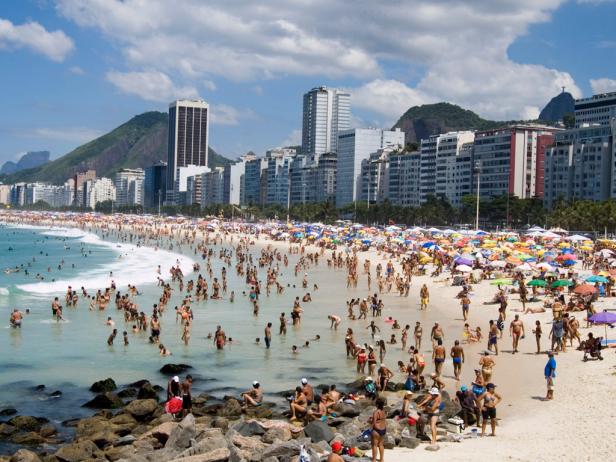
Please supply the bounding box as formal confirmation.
[336,128,404,207]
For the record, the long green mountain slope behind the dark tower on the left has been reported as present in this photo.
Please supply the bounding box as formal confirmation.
[1,111,232,184]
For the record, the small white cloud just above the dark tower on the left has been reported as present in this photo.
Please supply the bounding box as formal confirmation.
[106,71,199,102]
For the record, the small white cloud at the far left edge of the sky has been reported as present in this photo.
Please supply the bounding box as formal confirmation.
[0,18,75,62]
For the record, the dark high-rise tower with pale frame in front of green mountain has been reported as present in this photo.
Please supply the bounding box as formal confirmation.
[167,100,209,203]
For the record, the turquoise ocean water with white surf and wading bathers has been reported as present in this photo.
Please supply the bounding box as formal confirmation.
[0,226,376,426]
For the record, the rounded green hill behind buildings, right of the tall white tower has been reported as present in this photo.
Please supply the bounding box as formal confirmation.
[392,103,544,143]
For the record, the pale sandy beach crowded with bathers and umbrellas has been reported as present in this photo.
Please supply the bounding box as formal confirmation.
[0,211,616,461]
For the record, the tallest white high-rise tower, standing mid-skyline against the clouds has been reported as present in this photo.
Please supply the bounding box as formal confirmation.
[302,87,351,154]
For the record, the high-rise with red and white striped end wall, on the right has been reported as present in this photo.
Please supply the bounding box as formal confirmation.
[473,124,559,199]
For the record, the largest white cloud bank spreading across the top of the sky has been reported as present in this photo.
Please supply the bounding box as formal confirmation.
[58,0,580,120]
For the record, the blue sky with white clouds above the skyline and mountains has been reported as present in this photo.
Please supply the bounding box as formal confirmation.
[0,0,616,163]
